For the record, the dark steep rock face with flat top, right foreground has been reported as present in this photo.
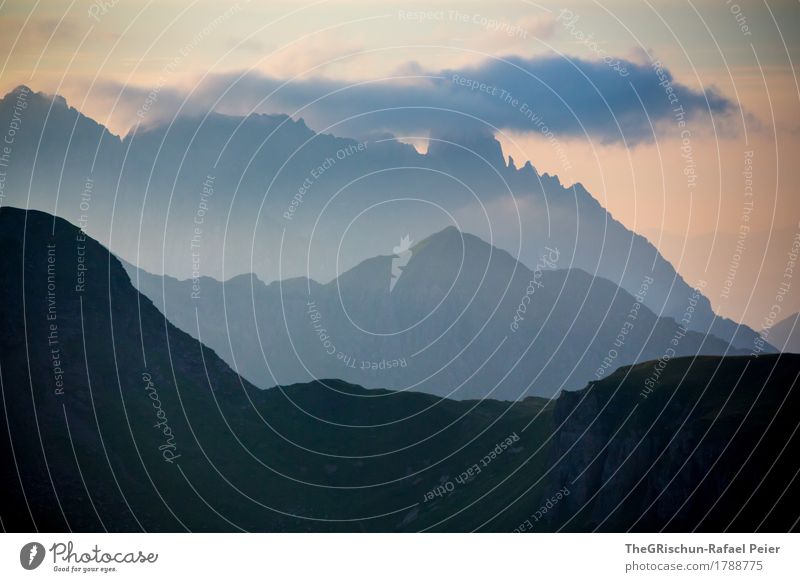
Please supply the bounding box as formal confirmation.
[541,355,800,531]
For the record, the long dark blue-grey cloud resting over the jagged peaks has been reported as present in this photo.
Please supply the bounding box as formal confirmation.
[97,55,736,145]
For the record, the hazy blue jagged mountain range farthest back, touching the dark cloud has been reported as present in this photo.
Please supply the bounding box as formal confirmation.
[0,87,761,351]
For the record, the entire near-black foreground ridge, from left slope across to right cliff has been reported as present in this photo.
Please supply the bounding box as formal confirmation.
[0,207,800,532]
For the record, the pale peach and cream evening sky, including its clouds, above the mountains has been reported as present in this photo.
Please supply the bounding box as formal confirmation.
[0,0,800,325]
